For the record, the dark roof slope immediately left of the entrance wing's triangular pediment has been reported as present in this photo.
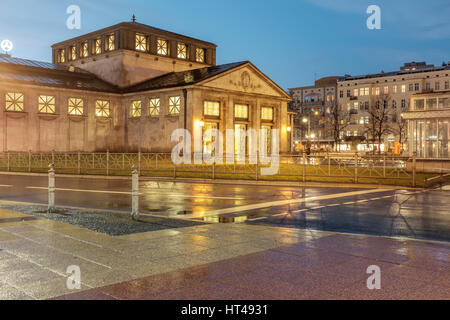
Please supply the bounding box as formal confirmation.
[125,61,249,92]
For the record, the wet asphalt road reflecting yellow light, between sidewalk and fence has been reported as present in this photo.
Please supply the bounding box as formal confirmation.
[0,175,450,241]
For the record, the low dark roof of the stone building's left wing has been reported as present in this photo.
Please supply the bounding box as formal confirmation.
[0,55,119,93]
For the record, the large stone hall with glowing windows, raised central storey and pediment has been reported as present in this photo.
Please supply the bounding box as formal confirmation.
[0,21,292,152]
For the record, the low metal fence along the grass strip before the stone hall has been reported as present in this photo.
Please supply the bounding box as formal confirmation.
[0,152,430,186]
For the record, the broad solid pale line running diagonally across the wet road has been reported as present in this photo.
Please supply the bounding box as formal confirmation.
[188,189,392,219]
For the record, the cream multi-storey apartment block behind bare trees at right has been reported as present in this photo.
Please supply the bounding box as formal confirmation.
[337,62,450,151]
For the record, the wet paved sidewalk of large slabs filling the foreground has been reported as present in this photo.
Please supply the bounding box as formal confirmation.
[0,209,450,300]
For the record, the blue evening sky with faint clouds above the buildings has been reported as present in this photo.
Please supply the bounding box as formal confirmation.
[0,0,450,89]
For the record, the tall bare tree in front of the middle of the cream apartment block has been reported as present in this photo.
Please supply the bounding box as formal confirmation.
[366,94,392,153]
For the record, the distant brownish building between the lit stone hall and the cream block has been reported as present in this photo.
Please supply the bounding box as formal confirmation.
[289,77,338,150]
